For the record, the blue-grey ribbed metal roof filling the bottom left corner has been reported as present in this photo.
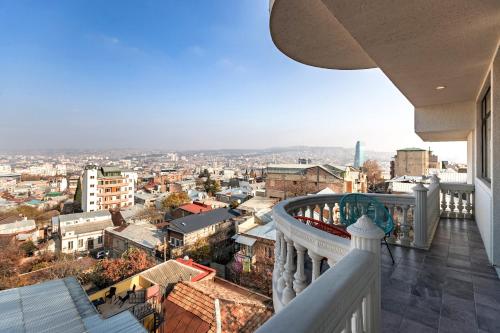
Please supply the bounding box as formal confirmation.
[0,277,146,333]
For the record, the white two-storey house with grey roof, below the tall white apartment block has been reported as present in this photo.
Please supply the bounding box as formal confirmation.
[52,211,113,253]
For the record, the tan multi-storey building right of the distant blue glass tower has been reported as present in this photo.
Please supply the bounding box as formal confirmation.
[391,148,439,178]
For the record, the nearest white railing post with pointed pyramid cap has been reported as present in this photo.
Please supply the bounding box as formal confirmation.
[347,215,384,333]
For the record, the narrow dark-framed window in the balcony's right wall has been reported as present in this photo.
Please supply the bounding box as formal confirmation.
[481,88,491,181]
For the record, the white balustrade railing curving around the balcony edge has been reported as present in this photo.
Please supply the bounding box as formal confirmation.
[259,176,474,332]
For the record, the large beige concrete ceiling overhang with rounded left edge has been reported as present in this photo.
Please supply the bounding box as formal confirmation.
[270,0,500,107]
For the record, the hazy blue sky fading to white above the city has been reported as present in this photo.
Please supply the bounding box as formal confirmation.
[0,0,466,161]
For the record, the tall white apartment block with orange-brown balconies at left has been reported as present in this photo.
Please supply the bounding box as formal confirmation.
[82,165,137,212]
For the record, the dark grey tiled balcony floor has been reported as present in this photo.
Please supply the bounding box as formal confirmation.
[382,219,500,333]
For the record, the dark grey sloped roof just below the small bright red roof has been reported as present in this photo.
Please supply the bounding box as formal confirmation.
[169,208,240,234]
